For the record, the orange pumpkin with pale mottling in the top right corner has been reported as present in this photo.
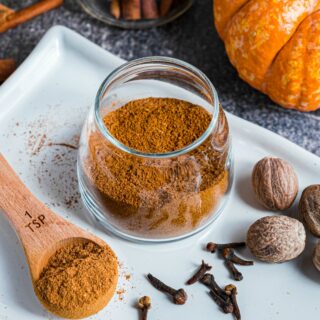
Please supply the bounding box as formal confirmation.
[214,0,320,111]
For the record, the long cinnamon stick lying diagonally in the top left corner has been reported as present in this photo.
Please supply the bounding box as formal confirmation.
[0,0,63,32]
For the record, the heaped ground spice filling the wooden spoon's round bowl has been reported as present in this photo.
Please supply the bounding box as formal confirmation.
[35,241,118,318]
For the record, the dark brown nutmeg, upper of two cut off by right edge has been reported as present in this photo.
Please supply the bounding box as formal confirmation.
[299,184,320,237]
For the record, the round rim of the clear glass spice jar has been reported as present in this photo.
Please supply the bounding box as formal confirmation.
[94,56,219,159]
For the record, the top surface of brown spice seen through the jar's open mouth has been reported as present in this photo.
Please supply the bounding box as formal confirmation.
[104,98,211,153]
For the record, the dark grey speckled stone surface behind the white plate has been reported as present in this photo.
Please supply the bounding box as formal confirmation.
[0,0,320,156]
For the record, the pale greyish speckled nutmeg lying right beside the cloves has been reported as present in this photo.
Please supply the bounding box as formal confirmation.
[247,216,306,263]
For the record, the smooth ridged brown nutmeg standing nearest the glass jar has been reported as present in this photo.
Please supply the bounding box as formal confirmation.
[252,157,298,210]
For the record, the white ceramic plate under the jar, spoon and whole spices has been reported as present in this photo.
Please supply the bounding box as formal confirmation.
[0,27,320,320]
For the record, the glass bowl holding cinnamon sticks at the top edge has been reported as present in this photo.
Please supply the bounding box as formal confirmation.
[78,0,194,29]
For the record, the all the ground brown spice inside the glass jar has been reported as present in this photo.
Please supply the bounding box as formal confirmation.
[83,98,229,238]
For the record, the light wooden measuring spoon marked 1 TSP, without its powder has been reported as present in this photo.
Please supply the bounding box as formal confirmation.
[0,153,118,318]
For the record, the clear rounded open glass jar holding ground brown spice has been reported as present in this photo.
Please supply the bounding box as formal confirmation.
[78,57,233,242]
